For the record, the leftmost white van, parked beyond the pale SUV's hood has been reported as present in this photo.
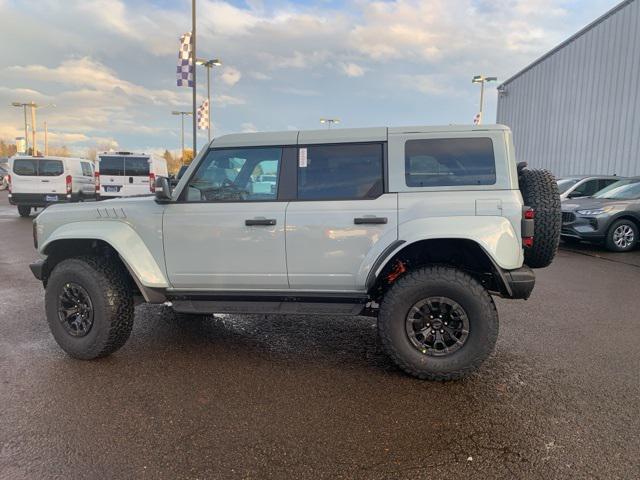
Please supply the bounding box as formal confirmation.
[9,156,95,217]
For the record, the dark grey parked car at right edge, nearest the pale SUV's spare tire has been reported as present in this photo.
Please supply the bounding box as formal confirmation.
[561,177,640,252]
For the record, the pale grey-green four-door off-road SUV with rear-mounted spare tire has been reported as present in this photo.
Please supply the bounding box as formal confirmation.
[31,125,561,379]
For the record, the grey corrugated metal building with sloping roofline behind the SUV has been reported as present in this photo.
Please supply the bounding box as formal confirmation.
[497,0,640,176]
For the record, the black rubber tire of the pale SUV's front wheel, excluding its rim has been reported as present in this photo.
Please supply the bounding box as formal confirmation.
[45,256,134,360]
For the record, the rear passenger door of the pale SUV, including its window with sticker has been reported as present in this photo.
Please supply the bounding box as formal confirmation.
[286,142,398,292]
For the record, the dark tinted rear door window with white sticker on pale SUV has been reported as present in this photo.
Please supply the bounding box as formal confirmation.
[298,143,383,200]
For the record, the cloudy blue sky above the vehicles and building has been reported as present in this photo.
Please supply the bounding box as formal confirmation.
[0,0,617,153]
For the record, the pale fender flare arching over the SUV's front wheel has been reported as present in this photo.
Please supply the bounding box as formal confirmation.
[39,221,169,288]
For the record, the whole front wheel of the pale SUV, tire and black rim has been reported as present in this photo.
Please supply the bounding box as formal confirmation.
[45,256,133,360]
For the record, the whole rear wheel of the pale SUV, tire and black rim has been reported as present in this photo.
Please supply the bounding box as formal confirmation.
[378,267,498,380]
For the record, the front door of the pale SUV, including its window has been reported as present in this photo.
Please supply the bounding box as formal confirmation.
[163,147,289,291]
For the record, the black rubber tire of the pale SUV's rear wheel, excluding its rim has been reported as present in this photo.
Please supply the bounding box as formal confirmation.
[378,266,498,380]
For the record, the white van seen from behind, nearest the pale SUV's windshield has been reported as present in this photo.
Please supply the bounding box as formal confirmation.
[96,152,168,198]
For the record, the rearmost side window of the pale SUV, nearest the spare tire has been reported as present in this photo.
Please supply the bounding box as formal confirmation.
[405,138,496,187]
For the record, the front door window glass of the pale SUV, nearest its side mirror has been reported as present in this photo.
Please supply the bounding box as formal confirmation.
[185,147,282,202]
